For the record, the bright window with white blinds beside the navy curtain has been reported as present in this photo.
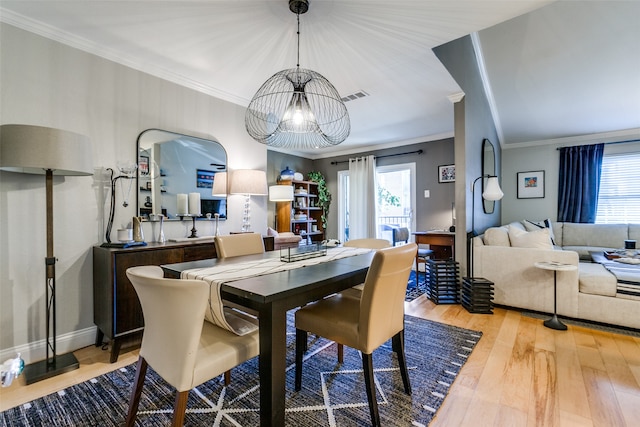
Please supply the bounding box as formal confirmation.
[596,153,640,224]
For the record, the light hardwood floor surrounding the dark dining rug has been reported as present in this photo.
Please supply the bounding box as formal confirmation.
[0,297,640,427]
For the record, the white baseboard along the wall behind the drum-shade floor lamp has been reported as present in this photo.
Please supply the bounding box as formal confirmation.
[0,326,96,365]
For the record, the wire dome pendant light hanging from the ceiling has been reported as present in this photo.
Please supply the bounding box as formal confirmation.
[245,0,351,149]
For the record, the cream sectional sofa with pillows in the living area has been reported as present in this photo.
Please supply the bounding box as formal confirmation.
[473,221,640,329]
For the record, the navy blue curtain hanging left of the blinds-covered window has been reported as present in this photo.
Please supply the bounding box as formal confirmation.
[558,144,604,223]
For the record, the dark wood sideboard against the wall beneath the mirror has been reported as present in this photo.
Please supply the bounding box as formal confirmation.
[93,236,273,363]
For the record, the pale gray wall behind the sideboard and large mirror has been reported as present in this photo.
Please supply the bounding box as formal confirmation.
[0,23,267,362]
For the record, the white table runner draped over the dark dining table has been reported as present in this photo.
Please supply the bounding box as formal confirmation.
[180,247,371,335]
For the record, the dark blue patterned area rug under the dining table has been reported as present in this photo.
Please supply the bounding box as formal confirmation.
[0,315,482,427]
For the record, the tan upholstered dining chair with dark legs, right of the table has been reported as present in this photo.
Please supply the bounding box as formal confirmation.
[295,243,417,426]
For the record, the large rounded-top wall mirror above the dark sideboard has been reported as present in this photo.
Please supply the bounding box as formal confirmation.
[137,129,227,220]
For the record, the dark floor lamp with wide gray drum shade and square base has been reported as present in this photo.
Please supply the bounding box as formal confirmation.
[0,125,93,384]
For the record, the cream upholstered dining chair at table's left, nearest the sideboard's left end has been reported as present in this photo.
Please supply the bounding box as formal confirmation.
[126,266,259,426]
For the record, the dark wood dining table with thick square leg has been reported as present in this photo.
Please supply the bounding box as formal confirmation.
[161,252,373,426]
